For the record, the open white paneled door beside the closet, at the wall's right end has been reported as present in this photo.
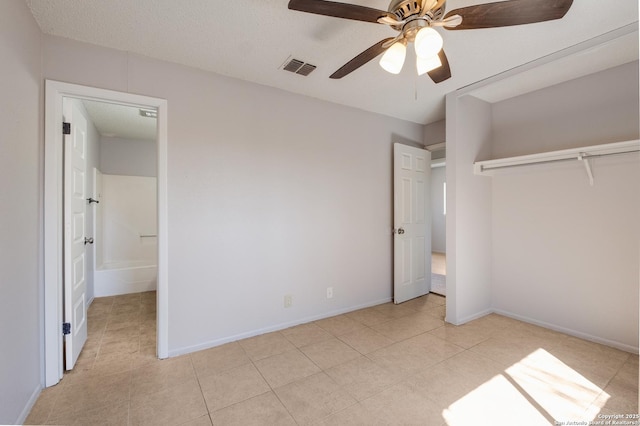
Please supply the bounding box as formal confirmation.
[393,143,431,304]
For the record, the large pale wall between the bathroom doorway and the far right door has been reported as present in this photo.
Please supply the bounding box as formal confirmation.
[43,36,422,354]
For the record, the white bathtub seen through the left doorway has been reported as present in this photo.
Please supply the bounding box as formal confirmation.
[93,261,158,297]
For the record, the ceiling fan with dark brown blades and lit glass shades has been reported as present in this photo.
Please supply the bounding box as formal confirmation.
[289,0,573,83]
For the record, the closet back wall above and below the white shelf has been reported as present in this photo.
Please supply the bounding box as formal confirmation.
[492,62,640,350]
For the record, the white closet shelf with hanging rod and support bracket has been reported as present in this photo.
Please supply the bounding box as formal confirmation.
[473,140,640,185]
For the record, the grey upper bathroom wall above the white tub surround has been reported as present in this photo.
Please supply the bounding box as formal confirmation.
[100,137,158,177]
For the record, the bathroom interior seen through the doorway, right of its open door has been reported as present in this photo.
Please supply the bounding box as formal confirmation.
[63,97,158,370]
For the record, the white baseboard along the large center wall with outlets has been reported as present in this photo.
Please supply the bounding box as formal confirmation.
[169,298,391,358]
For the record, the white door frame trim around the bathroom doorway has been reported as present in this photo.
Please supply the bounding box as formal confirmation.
[43,80,169,387]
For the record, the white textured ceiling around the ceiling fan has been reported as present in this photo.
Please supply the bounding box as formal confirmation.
[25,0,638,124]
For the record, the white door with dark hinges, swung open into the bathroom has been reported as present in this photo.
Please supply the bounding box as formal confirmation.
[63,99,87,370]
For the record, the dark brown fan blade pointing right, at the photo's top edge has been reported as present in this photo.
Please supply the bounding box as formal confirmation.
[445,0,573,30]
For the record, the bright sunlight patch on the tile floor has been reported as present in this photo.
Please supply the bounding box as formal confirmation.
[442,349,609,426]
